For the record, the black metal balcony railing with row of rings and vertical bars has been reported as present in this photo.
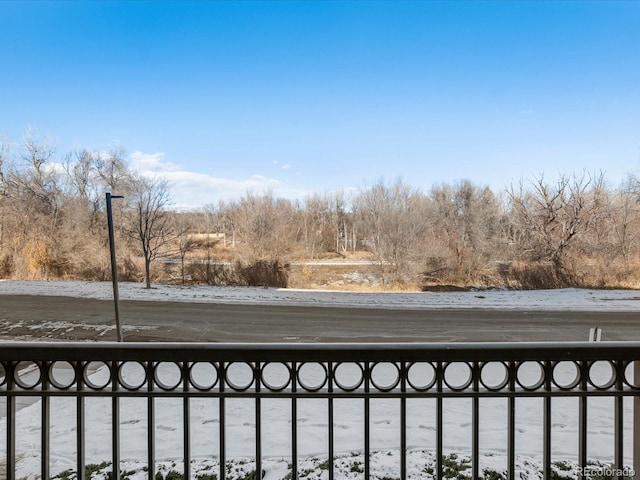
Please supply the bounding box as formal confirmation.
[0,342,640,480]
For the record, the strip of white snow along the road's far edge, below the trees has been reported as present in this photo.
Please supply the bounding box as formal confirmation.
[0,280,640,312]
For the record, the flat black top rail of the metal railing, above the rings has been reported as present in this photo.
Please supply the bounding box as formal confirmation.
[0,342,640,362]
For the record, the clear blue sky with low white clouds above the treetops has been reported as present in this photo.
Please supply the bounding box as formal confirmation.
[0,0,640,208]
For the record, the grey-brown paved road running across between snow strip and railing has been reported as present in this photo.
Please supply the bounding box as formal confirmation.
[0,295,640,342]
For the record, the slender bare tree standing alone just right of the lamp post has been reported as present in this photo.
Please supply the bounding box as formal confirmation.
[126,177,174,288]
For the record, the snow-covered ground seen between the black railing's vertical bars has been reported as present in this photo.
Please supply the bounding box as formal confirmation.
[0,364,632,479]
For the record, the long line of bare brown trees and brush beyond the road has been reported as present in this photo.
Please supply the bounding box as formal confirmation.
[0,130,640,288]
